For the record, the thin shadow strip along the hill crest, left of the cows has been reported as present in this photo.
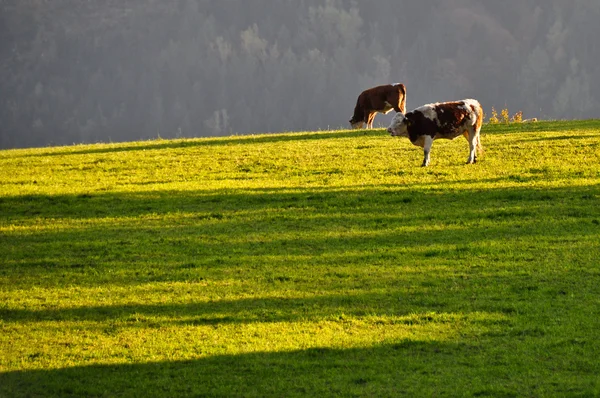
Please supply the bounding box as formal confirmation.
[15,130,372,158]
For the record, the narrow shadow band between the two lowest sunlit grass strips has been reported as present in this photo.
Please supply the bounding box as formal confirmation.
[0,287,506,326]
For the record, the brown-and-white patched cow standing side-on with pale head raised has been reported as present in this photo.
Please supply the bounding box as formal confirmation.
[388,99,483,167]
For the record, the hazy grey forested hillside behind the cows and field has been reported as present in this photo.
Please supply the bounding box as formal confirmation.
[0,0,600,148]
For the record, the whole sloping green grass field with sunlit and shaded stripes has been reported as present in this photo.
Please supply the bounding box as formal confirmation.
[0,120,600,397]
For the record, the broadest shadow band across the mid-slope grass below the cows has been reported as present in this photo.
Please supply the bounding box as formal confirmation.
[0,186,600,292]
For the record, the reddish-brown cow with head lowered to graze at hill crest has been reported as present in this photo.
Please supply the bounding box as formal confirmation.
[350,83,406,129]
